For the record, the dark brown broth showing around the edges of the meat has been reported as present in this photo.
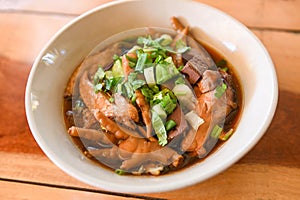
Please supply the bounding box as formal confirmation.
[63,43,243,175]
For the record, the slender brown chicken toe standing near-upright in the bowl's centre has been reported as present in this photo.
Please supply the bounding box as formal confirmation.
[135,90,152,138]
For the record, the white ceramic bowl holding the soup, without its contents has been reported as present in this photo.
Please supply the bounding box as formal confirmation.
[26,0,278,193]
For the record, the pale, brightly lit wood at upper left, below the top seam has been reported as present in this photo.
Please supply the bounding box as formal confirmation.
[0,13,74,63]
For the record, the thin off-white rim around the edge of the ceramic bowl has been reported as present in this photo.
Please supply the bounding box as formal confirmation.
[25,0,278,193]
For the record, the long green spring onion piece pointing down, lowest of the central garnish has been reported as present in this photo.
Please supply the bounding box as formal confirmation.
[151,110,168,146]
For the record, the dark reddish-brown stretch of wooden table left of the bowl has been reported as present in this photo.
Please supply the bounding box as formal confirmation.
[0,57,42,154]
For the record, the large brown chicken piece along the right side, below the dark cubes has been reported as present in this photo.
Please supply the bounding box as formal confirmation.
[182,70,236,157]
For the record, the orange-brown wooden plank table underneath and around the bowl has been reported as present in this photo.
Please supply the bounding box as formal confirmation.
[0,0,300,200]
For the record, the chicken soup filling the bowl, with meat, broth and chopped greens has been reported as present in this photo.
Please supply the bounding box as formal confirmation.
[64,18,242,175]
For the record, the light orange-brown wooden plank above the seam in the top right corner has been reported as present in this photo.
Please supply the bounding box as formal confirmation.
[198,0,300,31]
